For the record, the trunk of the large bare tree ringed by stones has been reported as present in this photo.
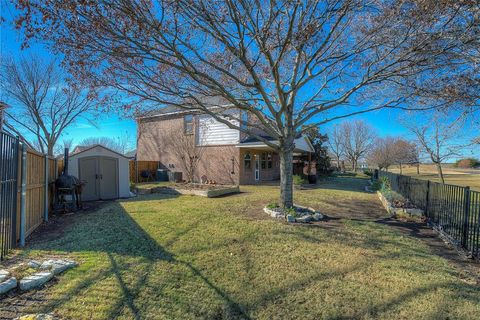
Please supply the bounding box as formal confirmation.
[279,141,293,208]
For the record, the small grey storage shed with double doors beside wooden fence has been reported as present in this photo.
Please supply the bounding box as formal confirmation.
[68,144,130,201]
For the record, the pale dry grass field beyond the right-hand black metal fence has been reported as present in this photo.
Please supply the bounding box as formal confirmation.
[389,164,480,191]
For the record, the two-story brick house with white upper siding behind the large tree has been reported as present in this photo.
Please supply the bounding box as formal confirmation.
[137,106,313,184]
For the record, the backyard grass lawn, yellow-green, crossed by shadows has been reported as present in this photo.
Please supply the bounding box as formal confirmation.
[0,178,480,319]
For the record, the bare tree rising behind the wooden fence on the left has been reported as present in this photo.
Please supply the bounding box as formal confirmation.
[0,56,94,155]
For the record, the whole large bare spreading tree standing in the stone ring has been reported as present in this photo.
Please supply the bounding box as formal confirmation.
[14,0,460,207]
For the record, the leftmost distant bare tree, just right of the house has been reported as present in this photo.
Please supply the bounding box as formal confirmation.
[340,120,375,172]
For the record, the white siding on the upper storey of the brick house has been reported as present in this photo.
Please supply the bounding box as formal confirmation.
[197,115,240,146]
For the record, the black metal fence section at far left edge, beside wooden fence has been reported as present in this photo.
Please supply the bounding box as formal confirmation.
[0,131,19,260]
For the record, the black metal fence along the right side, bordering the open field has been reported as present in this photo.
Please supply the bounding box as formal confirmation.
[378,171,480,258]
